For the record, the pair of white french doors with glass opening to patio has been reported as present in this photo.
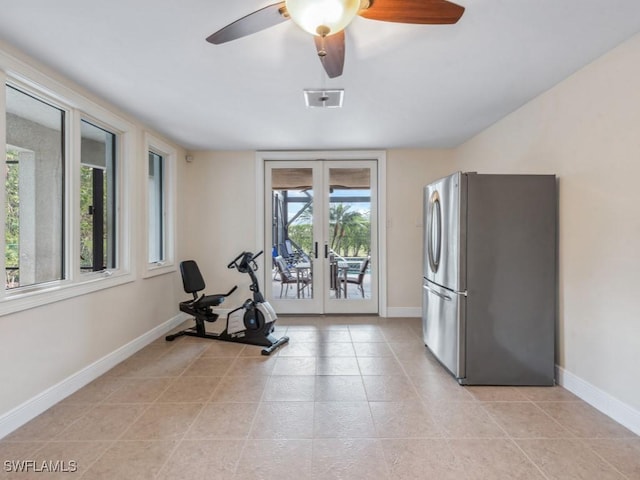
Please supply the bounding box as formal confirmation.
[264,160,379,314]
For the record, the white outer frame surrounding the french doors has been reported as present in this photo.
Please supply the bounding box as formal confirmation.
[255,150,387,317]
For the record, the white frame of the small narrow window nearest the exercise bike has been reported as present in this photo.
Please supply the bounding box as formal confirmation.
[140,132,178,278]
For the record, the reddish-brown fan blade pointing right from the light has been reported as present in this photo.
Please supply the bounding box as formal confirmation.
[358,0,464,25]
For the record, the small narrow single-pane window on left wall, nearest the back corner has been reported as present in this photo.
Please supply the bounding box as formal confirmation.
[145,134,177,276]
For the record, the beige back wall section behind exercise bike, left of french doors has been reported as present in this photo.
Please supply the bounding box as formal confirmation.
[178,152,261,296]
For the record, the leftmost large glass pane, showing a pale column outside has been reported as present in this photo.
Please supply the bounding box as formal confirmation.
[5,85,65,289]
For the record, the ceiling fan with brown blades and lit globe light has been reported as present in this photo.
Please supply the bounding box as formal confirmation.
[207,0,464,78]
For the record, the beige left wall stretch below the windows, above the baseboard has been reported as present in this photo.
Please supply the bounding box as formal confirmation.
[0,274,177,412]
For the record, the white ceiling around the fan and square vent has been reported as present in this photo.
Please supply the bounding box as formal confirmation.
[0,0,640,150]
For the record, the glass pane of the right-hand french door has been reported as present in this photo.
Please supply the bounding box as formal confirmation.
[328,168,371,300]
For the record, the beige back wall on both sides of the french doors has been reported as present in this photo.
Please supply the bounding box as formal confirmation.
[179,150,452,315]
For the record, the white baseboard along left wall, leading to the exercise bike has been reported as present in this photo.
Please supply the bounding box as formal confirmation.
[0,313,189,439]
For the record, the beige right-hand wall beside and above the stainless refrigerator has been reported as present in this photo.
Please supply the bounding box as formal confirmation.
[455,35,640,410]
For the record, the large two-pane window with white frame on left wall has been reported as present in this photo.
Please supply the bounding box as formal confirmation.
[0,71,134,315]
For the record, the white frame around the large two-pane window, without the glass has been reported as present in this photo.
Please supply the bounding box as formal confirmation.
[0,62,137,316]
